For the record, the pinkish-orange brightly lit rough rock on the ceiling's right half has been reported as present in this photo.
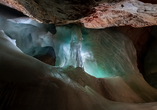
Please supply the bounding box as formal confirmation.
[80,0,157,28]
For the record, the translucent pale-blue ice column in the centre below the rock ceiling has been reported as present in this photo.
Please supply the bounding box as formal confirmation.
[53,25,83,68]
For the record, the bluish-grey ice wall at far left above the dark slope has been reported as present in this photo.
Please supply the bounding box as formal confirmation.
[0,17,55,55]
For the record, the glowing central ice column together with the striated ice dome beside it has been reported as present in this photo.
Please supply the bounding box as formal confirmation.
[56,26,138,78]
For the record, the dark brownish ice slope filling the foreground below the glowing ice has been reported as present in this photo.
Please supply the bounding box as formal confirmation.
[0,27,157,110]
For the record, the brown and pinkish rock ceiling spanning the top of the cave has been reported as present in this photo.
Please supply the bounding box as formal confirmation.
[0,0,157,28]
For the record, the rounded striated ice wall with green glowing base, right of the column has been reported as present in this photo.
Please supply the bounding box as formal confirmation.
[82,29,139,77]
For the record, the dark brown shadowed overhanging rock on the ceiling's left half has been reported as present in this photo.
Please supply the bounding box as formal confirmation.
[0,0,96,24]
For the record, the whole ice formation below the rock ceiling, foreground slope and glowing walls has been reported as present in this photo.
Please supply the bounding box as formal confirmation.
[0,16,157,110]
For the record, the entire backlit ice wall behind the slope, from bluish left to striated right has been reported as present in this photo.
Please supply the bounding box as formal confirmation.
[0,17,139,78]
